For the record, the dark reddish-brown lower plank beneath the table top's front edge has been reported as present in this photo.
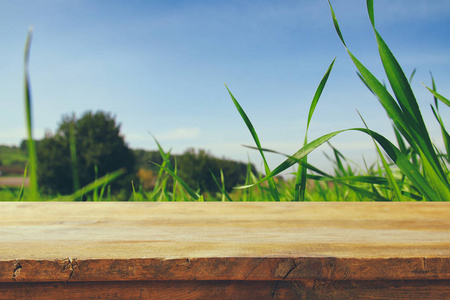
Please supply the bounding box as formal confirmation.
[0,280,450,300]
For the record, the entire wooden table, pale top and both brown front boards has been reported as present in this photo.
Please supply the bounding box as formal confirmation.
[0,202,450,299]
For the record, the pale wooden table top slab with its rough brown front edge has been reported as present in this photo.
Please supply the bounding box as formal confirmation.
[0,202,450,282]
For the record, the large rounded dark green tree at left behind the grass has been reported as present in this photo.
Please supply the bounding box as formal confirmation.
[37,111,135,195]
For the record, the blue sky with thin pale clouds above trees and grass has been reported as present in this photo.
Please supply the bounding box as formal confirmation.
[0,0,450,169]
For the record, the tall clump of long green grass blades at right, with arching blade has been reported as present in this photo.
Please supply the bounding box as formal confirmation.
[220,0,450,201]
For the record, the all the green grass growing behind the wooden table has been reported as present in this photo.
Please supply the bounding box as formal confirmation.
[9,0,450,201]
